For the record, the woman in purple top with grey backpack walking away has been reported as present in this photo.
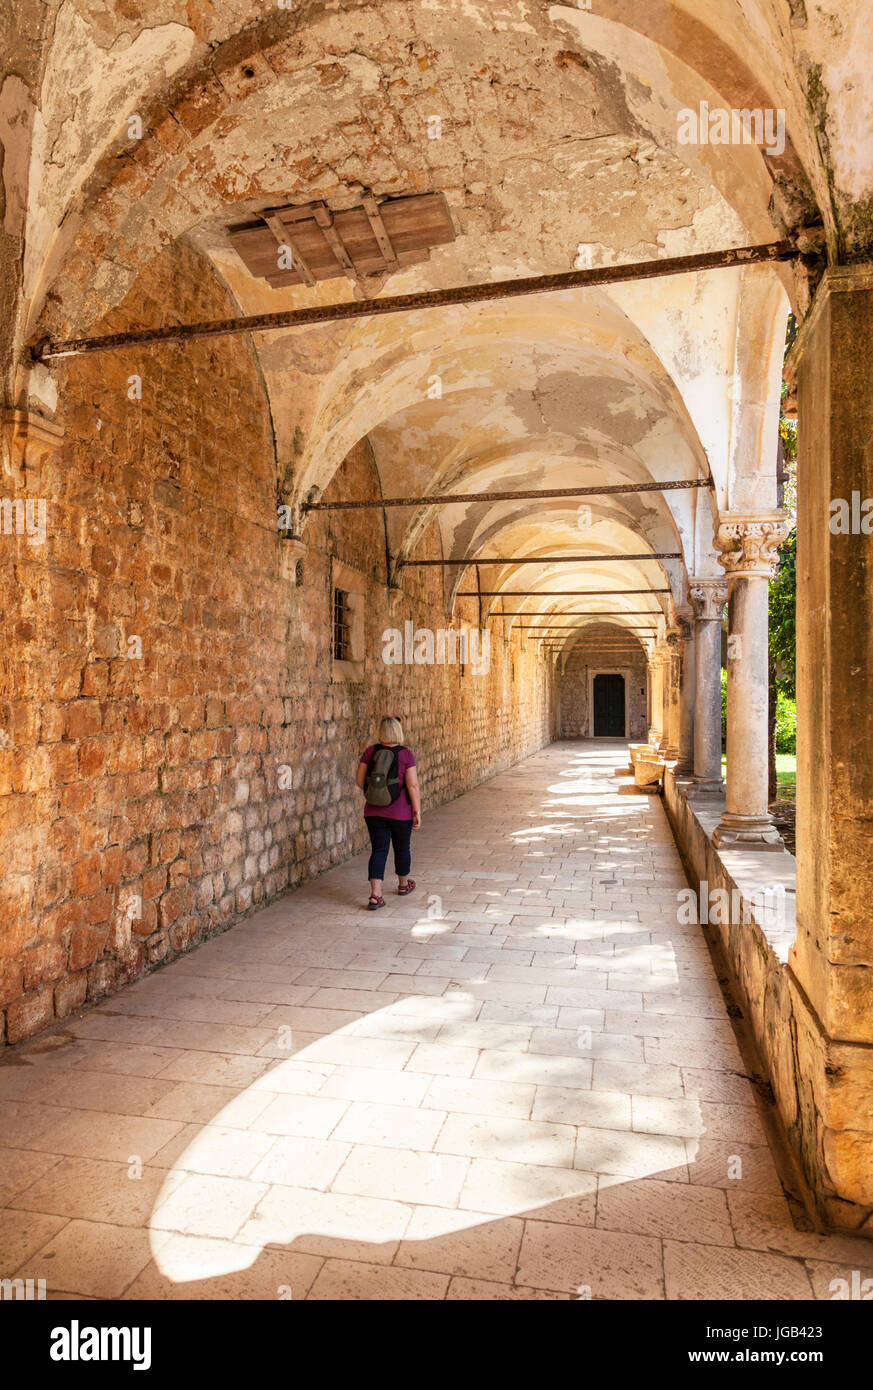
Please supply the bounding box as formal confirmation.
[356,716,421,912]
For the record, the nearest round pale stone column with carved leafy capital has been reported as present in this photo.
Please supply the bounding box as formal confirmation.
[713,512,788,851]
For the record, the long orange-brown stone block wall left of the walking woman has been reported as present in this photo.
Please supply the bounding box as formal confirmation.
[0,247,550,1044]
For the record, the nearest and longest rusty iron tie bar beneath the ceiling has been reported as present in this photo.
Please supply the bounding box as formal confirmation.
[31,240,799,361]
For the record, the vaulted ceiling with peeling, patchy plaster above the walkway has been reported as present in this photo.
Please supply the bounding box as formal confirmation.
[6,0,873,644]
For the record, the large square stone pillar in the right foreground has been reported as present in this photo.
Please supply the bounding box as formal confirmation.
[783,264,873,1234]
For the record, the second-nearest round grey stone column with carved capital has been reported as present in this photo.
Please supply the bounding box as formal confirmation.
[690,578,727,796]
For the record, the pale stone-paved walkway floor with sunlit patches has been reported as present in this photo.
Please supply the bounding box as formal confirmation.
[0,742,873,1300]
